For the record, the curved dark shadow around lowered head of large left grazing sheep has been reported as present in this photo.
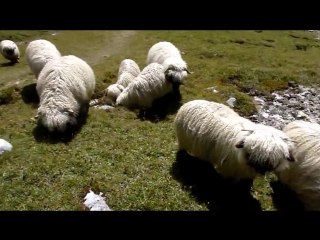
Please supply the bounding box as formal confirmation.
[32,107,89,144]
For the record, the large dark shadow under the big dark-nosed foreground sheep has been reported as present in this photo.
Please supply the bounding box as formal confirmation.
[170,151,262,211]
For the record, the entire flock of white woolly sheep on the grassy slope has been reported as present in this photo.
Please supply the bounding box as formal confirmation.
[0,36,320,211]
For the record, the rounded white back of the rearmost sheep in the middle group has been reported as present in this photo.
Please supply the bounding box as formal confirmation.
[147,42,181,64]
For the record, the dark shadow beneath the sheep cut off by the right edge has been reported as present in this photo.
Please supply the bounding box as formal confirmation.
[270,180,305,211]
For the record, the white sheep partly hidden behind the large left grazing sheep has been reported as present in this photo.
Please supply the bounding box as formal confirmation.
[26,39,61,79]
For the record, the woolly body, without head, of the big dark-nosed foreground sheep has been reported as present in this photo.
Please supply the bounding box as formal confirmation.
[174,100,241,160]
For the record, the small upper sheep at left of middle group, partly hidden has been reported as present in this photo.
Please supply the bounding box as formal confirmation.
[116,59,140,87]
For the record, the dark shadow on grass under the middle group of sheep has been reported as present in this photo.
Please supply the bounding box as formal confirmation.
[137,91,182,122]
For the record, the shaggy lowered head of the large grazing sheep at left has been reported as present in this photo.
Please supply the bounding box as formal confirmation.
[34,107,77,132]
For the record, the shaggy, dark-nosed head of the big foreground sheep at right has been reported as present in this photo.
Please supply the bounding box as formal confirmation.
[235,124,296,174]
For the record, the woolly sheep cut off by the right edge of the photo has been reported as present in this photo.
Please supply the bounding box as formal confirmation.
[276,120,320,211]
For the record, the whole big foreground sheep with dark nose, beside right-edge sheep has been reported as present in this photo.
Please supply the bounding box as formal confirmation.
[174,100,295,183]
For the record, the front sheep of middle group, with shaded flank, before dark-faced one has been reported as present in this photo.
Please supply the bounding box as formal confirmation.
[116,63,172,109]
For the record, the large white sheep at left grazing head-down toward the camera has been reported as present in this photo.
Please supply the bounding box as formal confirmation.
[34,55,96,132]
